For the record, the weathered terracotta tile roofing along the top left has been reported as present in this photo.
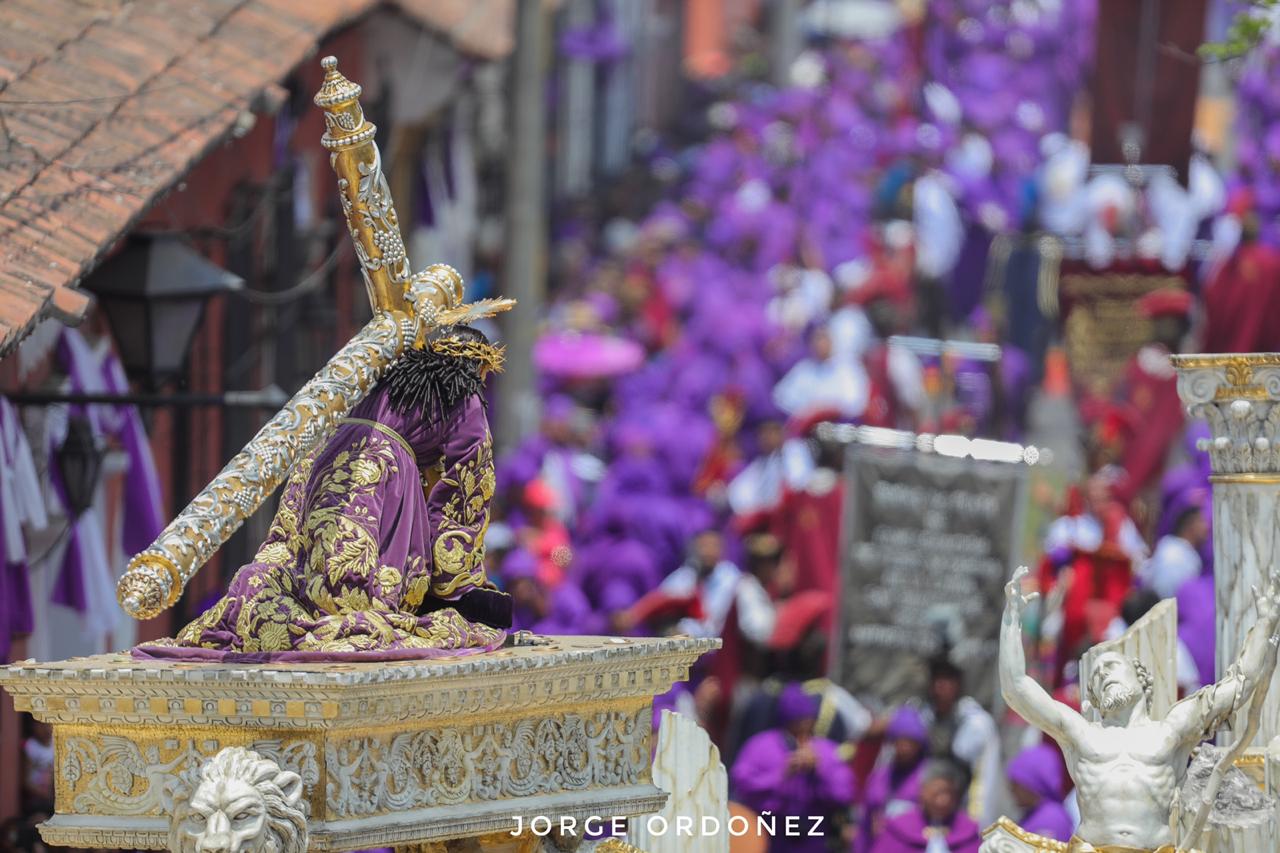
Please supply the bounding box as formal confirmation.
[0,0,515,357]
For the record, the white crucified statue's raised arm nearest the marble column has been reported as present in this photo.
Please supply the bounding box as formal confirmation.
[1165,575,1280,743]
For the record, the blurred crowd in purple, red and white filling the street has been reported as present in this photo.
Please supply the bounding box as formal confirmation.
[476,4,1280,853]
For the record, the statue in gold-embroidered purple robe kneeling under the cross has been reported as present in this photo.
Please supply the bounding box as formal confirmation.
[133,325,512,662]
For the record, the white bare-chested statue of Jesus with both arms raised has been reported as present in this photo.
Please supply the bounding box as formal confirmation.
[1000,567,1280,853]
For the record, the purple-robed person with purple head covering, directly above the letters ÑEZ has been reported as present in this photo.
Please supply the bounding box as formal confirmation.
[730,684,854,853]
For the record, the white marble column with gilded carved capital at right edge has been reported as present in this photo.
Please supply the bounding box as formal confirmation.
[1172,352,1280,747]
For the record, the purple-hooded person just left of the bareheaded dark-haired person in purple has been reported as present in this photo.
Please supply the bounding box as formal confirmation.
[854,706,929,853]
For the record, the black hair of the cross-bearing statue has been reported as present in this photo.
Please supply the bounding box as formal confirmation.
[383,325,489,423]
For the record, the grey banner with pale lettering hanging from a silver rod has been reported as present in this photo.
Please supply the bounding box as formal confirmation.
[836,446,1028,703]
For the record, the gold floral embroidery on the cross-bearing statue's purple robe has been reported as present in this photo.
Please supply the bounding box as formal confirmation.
[166,414,503,652]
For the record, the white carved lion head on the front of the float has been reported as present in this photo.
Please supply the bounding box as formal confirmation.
[169,747,307,853]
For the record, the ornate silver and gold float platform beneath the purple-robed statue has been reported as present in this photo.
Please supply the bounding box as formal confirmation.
[0,637,719,850]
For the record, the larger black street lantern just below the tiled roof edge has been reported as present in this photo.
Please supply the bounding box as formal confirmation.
[84,234,244,388]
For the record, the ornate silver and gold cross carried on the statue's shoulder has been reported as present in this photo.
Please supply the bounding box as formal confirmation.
[116,56,513,619]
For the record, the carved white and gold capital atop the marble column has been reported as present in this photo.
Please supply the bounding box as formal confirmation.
[1174,352,1280,478]
